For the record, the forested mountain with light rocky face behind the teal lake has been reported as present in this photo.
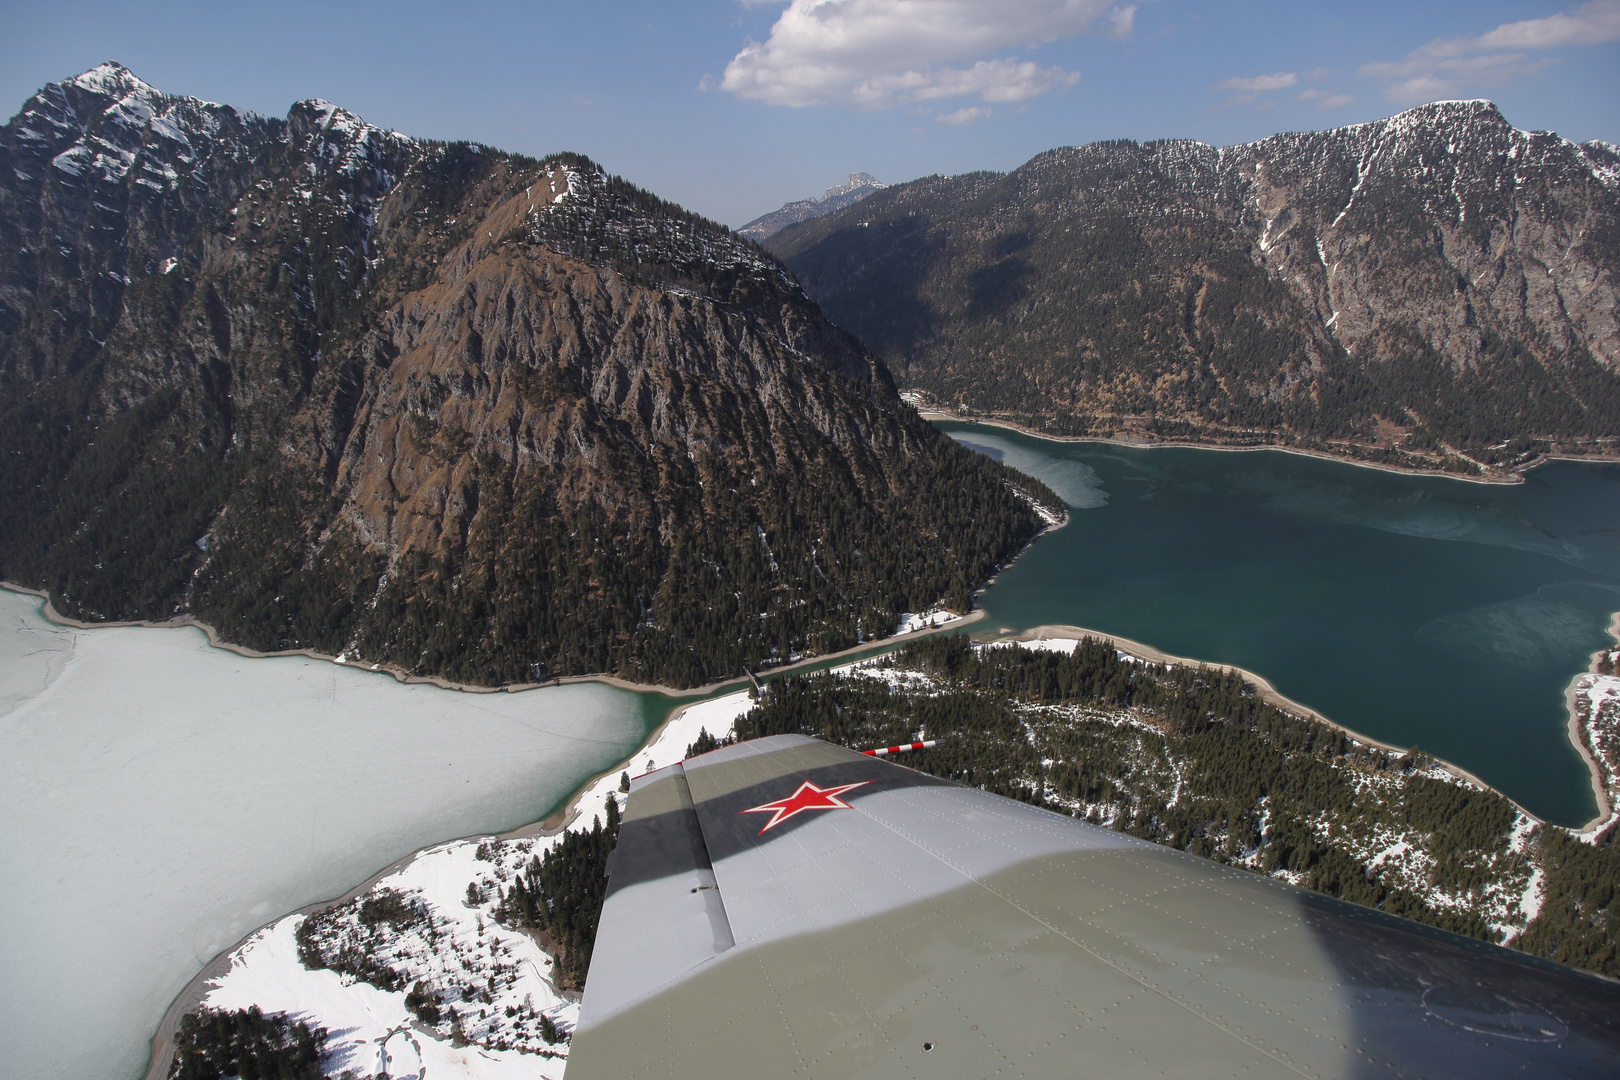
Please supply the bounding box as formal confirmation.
[770,102,1620,468]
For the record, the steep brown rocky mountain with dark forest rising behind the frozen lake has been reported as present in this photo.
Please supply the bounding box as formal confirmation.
[0,65,1061,683]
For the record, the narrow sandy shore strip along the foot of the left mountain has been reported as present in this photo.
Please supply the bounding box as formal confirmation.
[0,582,972,698]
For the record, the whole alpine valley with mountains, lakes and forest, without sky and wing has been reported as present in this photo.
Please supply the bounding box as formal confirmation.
[0,62,1620,1080]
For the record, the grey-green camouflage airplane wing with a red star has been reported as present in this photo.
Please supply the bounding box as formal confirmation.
[569,735,1620,1080]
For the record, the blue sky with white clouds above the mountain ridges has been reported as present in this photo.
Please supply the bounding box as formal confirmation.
[9,0,1620,227]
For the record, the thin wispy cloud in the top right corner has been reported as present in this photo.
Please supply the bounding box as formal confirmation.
[1358,0,1620,104]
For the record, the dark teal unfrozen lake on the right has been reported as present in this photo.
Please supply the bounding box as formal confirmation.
[940,423,1620,826]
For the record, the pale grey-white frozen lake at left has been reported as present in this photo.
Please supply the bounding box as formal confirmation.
[0,591,669,1080]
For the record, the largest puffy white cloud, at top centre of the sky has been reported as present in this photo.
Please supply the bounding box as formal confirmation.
[719,0,1136,108]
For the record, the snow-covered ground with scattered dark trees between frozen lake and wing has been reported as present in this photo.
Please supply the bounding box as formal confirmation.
[187,691,753,1080]
